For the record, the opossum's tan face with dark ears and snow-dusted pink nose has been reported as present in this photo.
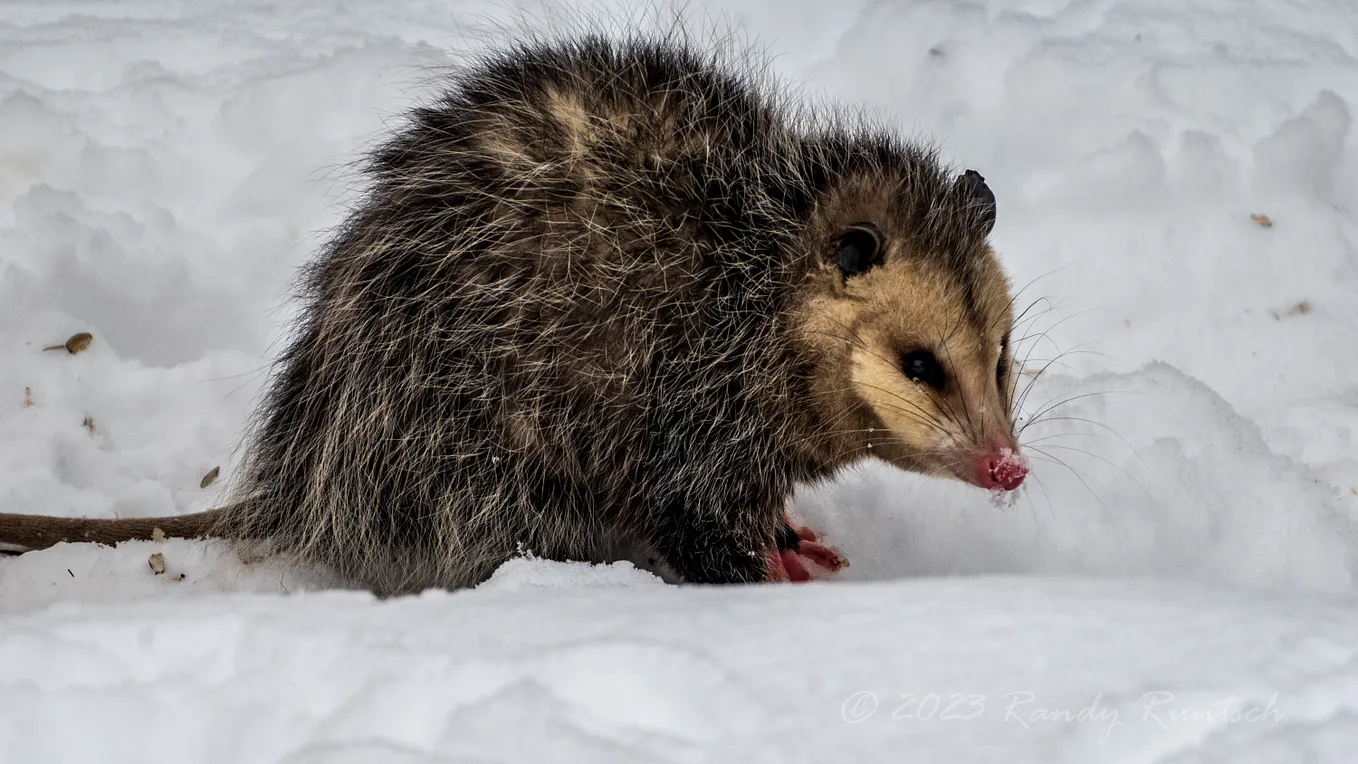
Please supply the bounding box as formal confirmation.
[801,172,1027,490]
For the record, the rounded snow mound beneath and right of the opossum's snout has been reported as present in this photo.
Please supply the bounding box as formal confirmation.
[800,364,1358,592]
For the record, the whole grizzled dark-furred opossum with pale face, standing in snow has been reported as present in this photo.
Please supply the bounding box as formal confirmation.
[0,29,1027,593]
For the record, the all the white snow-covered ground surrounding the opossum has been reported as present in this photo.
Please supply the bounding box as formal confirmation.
[0,0,1358,764]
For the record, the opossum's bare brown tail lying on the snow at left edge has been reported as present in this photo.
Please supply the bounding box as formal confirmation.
[0,508,230,551]
